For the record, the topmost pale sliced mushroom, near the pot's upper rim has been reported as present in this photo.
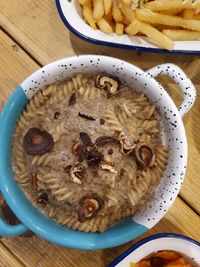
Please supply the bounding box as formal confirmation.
[95,75,119,95]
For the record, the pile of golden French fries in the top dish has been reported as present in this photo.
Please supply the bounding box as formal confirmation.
[77,0,200,50]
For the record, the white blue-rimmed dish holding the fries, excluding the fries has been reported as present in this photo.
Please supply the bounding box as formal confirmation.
[56,0,200,55]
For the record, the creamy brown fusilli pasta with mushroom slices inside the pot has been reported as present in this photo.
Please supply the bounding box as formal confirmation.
[13,73,168,232]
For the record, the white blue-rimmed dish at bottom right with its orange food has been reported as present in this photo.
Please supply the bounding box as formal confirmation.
[108,233,200,267]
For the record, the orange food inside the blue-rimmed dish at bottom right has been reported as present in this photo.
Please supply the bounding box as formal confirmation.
[130,250,198,267]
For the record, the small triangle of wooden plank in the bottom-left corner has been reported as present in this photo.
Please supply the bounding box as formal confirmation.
[0,242,25,267]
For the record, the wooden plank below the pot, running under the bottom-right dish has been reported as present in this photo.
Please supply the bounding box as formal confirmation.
[3,198,200,267]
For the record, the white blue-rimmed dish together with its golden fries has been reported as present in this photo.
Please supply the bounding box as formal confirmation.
[56,0,200,54]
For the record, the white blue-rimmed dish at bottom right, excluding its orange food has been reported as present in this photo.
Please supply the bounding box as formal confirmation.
[108,233,200,267]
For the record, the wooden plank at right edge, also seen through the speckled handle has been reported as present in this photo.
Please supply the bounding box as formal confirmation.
[160,58,200,215]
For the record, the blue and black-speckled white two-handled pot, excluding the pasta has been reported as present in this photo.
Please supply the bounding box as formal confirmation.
[0,55,196,249]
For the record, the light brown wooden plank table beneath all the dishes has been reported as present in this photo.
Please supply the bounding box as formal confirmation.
[0,0,200,267]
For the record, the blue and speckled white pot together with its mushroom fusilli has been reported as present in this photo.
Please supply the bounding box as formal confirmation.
[0,55,196,249]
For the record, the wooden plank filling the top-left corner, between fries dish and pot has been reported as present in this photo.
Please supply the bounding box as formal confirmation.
[0,0,197,69]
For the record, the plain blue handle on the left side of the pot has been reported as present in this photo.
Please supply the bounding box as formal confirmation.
[0,188,29,236]
